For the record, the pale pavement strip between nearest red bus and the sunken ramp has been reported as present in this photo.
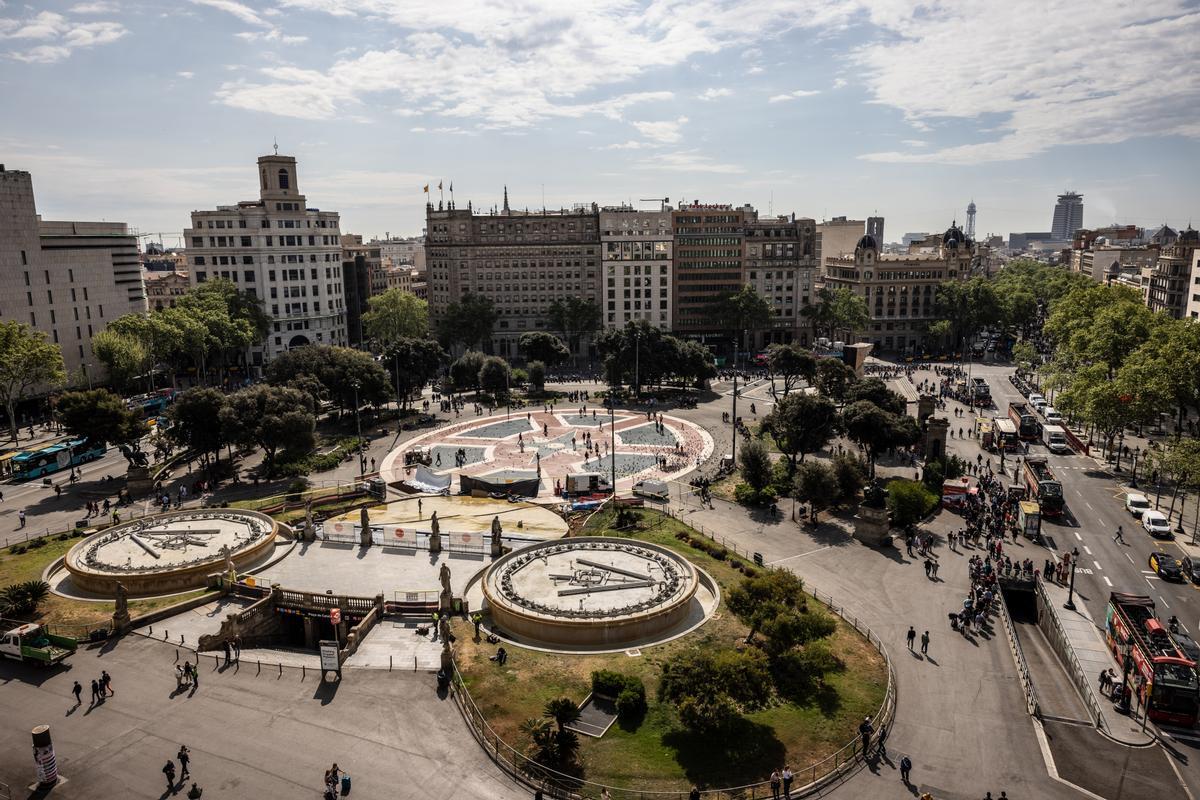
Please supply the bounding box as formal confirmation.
[1042,581,1154,746]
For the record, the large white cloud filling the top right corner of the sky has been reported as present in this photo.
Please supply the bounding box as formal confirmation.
[853,0,1200,164]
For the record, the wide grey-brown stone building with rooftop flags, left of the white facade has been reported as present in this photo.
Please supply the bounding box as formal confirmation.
[425,196,602,357]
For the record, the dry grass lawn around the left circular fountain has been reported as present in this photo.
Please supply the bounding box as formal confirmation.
[0,535,214,636]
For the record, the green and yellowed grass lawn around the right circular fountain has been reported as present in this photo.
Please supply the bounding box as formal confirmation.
[456,512,887,790]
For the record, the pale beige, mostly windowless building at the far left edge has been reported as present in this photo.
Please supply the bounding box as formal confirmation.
[0,164,146,385]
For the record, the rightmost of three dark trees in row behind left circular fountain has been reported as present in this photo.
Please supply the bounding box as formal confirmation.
[221,384,316,475]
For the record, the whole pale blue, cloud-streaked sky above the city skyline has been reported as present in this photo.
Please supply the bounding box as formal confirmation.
[0,0,1200,245]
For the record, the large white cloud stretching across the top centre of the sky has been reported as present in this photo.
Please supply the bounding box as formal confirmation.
[211,0,860,123]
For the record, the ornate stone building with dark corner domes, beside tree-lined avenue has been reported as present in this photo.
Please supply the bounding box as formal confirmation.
[824,225,974,353]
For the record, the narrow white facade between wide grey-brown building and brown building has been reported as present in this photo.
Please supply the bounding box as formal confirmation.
[600,205,674,331]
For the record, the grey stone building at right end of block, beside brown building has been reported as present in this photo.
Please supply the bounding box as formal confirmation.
[744,212,820,349]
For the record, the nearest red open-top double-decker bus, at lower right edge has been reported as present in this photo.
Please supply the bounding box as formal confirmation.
[1104,591,1200,728]
